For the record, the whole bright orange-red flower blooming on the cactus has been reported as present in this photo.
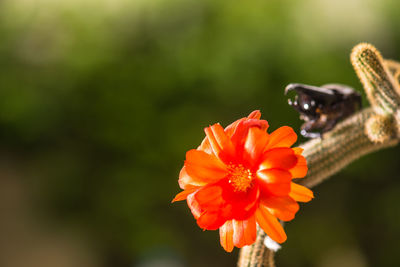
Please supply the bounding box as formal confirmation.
[173,110,313,252]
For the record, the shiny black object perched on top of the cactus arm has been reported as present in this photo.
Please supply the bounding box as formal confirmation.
[285,83,361,138]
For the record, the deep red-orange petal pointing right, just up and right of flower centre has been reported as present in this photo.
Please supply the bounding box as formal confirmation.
[259,147,297,169]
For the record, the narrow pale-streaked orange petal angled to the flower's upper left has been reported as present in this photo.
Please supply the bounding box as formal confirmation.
[204,123,235,163]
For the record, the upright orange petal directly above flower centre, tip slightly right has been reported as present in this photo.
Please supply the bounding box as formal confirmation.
[244,127,269,165]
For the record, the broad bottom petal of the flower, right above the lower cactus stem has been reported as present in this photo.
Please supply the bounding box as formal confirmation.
[232,215,257,248]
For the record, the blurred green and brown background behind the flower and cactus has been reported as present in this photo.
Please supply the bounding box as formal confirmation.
[0,0,400,267]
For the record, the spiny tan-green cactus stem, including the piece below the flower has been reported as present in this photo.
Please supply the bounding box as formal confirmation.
[238,43,400,267]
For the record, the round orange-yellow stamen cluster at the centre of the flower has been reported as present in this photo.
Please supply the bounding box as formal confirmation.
[228,164,253,192]
